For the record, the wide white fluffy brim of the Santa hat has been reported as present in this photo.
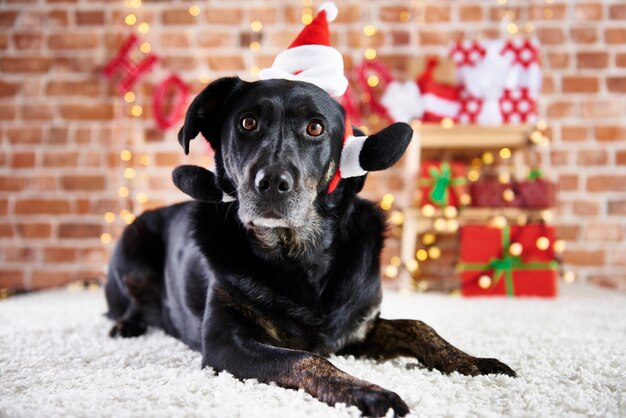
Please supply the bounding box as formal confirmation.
[259,45,348,97]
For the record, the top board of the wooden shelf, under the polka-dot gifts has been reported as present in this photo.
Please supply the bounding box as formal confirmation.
[413,123,531,149]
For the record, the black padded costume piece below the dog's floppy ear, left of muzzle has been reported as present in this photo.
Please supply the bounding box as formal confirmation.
[172,165,223,202]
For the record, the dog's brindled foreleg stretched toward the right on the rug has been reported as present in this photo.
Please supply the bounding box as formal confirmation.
[340,318,515,376]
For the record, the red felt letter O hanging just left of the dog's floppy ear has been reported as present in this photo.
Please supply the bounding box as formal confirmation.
[152,74,189,129]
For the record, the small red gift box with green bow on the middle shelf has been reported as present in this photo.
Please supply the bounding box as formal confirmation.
[419,161,467,208]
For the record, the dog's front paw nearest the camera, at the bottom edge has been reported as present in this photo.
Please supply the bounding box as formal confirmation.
[335,385,409,417]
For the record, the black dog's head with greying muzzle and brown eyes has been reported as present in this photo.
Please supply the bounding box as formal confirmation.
[175,78,411,229]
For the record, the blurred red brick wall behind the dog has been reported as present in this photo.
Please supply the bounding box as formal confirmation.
[0,0,626,289]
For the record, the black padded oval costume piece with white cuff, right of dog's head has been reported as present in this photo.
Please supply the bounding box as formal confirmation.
[359,122,413,171]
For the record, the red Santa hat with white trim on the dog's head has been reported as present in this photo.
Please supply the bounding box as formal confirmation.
[259,1,348,97]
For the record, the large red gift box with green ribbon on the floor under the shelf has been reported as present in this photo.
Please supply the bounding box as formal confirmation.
[459,224,558,297]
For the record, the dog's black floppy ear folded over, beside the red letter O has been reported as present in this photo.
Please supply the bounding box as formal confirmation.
[178,77,247,154]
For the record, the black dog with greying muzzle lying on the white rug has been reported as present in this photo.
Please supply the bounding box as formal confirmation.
[106,78,515,416]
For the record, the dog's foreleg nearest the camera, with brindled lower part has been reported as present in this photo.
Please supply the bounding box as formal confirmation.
[202,306,409,416]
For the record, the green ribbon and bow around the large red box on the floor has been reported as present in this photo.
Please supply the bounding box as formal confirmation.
[461,225,558,296]
